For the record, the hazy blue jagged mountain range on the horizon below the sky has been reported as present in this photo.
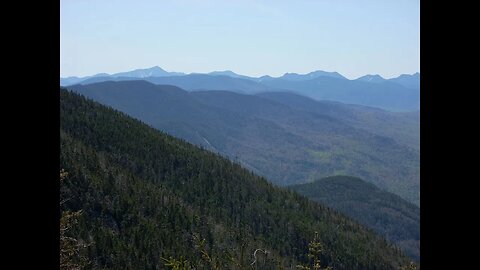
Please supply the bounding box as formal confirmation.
[60,66,420,111]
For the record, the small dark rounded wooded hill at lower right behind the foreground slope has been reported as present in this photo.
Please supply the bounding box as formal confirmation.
[289,176,420,262]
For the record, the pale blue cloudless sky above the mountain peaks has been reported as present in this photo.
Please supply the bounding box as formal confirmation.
[60,0,420,79]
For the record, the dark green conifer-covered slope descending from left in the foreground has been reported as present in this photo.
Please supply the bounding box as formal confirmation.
[60,90,408,270]
